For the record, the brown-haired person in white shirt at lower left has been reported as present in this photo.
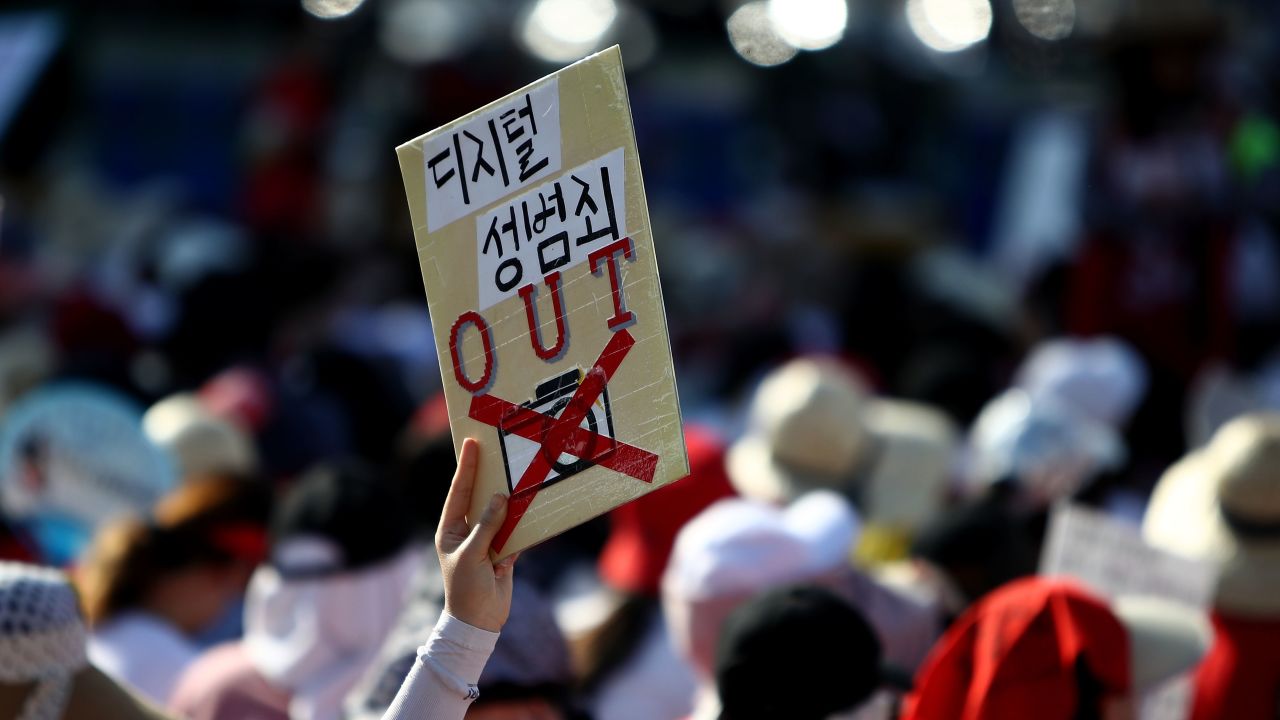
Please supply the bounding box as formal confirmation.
[76,477,270,705]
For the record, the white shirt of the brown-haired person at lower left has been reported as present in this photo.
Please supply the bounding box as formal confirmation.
[88,612,200,707]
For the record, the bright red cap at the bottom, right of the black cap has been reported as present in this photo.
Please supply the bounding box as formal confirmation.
[902,578,1132,720]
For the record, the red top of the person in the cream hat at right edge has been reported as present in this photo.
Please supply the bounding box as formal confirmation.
[1192,612,1280,720]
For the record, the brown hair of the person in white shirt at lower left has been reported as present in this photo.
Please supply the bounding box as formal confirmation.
[76,477,270,624]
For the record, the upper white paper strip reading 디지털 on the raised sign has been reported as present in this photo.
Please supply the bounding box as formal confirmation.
[422,78,561,232]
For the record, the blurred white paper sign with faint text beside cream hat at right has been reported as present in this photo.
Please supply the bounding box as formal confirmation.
[1041,503,1216,720]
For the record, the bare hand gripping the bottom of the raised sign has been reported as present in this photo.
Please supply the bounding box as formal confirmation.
[435,438,516,633]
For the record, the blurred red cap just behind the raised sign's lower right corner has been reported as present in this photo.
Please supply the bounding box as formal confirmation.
[599,427,735,596]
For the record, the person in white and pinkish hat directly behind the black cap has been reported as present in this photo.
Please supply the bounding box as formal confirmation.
[662,491,937,720]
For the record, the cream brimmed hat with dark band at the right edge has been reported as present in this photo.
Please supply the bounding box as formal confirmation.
[1142,413,1280,618]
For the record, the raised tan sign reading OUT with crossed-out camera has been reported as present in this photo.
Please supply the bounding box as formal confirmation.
[396,46,689,557]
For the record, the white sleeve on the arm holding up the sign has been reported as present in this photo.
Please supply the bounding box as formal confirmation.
[383,612,498,720]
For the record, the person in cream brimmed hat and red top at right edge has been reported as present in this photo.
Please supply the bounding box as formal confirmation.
[1143,413,1280,720]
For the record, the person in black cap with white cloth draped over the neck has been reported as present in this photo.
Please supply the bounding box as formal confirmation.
[169,461,421,720]
